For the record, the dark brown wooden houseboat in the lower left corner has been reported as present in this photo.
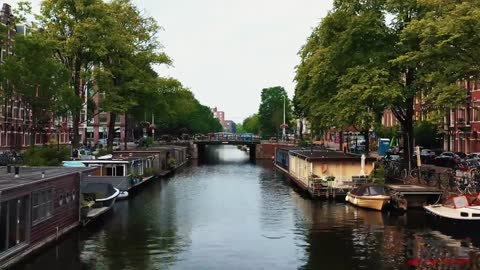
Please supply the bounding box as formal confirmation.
[0,167,96,269]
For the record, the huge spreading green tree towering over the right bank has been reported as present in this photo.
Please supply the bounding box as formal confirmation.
[294,0,480,165]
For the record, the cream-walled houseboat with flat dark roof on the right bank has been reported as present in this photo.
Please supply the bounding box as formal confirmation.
[275,148,375,198]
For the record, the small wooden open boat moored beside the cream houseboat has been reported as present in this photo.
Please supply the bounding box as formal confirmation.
[345,184,390,211]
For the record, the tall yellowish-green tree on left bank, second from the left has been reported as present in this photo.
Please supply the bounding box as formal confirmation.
[37,0,111,146]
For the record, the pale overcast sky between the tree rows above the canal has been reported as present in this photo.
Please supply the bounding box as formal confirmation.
[7,0,333,123]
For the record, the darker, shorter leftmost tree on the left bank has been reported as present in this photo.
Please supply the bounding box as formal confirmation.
[0,30,68,146]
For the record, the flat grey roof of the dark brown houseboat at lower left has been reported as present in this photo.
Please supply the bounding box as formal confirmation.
[0,167,96,190]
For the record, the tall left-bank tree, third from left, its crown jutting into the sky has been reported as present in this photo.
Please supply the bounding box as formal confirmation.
[96,0,170,147]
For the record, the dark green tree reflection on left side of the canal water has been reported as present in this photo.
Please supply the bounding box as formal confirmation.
[96,179,188,269]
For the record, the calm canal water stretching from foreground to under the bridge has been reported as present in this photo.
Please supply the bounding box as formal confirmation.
[16,146,480,269]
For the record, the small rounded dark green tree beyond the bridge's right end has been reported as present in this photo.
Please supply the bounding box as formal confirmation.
[258,86,292,136]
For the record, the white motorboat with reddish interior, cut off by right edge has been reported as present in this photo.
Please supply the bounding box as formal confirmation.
[423,194,480,221]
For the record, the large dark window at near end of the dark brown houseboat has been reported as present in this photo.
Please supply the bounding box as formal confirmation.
[0,195,28,252]
